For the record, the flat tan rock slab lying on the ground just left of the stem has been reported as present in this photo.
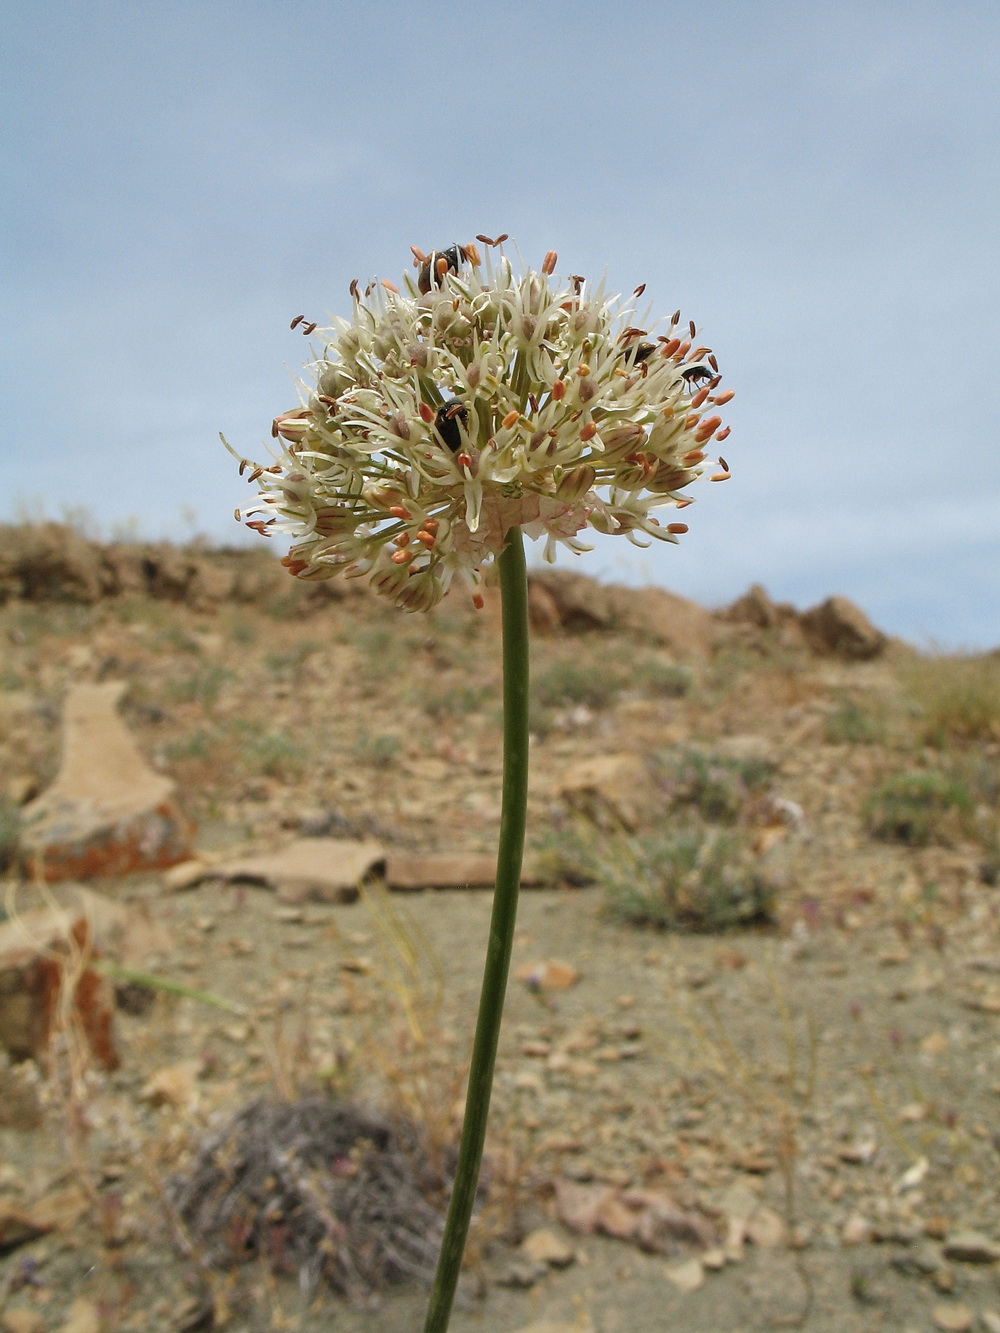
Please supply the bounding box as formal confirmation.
[211,837,385,902]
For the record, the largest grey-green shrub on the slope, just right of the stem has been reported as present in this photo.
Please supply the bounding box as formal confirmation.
[597,826,775,932]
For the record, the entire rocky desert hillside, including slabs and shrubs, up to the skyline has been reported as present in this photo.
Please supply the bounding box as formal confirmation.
[0,525,1000,1333]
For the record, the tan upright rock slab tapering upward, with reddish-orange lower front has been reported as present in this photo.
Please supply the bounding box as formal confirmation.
[21,681,193,881]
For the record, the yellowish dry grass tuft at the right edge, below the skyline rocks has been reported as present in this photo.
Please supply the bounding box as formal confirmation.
[903,653,1000,746]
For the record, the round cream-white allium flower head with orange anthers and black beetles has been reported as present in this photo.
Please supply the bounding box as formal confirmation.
[237,237,732,611]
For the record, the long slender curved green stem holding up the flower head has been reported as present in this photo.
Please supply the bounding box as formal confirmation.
[424,528,528,1333]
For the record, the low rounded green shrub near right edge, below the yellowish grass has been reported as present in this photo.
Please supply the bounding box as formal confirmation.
[863,769,976,846]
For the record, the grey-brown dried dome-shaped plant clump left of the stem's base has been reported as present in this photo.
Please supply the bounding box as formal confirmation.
[171,1094,445,1298]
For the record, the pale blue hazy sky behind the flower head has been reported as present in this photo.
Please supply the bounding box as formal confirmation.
[0,0,1000,647]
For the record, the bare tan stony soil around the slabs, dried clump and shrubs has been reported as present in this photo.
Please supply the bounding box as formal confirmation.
[0,533,1000,1333]
